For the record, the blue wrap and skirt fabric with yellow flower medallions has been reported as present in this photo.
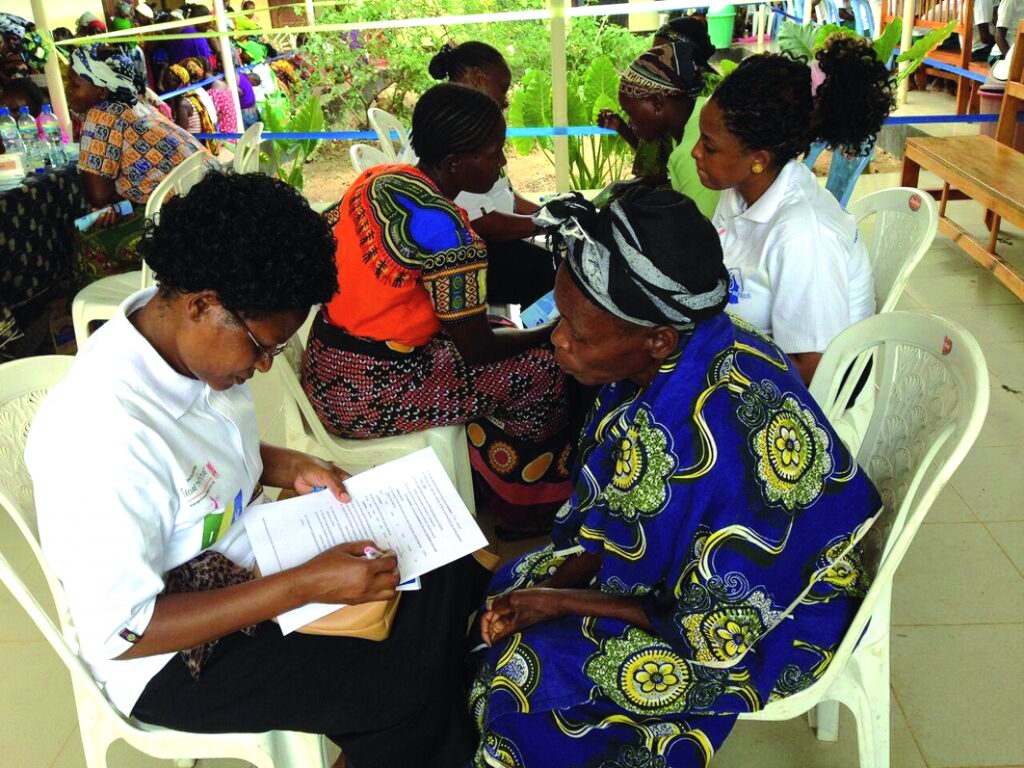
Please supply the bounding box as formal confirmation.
[470,314,882,768]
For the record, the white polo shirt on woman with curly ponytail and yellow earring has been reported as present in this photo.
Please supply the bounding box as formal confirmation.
[712,160,874,353]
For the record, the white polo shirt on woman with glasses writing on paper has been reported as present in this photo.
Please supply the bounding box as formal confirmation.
[25,289,263,715]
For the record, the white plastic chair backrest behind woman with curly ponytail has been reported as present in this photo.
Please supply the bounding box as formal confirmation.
[847,186,939,312]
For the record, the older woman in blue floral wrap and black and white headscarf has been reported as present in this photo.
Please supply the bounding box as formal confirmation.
[471,187,882,768]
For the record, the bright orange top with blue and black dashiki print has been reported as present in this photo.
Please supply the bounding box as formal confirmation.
[325,165,487,347]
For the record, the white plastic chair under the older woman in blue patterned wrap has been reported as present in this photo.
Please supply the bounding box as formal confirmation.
[740,312,988,768]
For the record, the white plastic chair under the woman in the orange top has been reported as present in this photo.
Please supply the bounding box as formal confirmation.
[269,337,476,515]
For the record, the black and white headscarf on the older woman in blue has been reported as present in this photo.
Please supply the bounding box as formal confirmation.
[536,186,729,330]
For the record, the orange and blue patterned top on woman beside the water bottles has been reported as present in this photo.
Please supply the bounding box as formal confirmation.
[78,101,205,205]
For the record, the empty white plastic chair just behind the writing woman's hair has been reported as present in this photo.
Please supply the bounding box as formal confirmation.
[71,152,211,347]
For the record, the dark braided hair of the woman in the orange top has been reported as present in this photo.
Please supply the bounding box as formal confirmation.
[412,83,502,165]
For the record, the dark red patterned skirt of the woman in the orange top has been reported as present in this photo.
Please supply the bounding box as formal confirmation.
[302,315,572,527]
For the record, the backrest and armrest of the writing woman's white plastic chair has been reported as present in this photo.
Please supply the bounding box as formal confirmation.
[0,355,123,721]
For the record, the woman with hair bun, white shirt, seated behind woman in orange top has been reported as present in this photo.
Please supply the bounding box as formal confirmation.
[423,40,555,306]
